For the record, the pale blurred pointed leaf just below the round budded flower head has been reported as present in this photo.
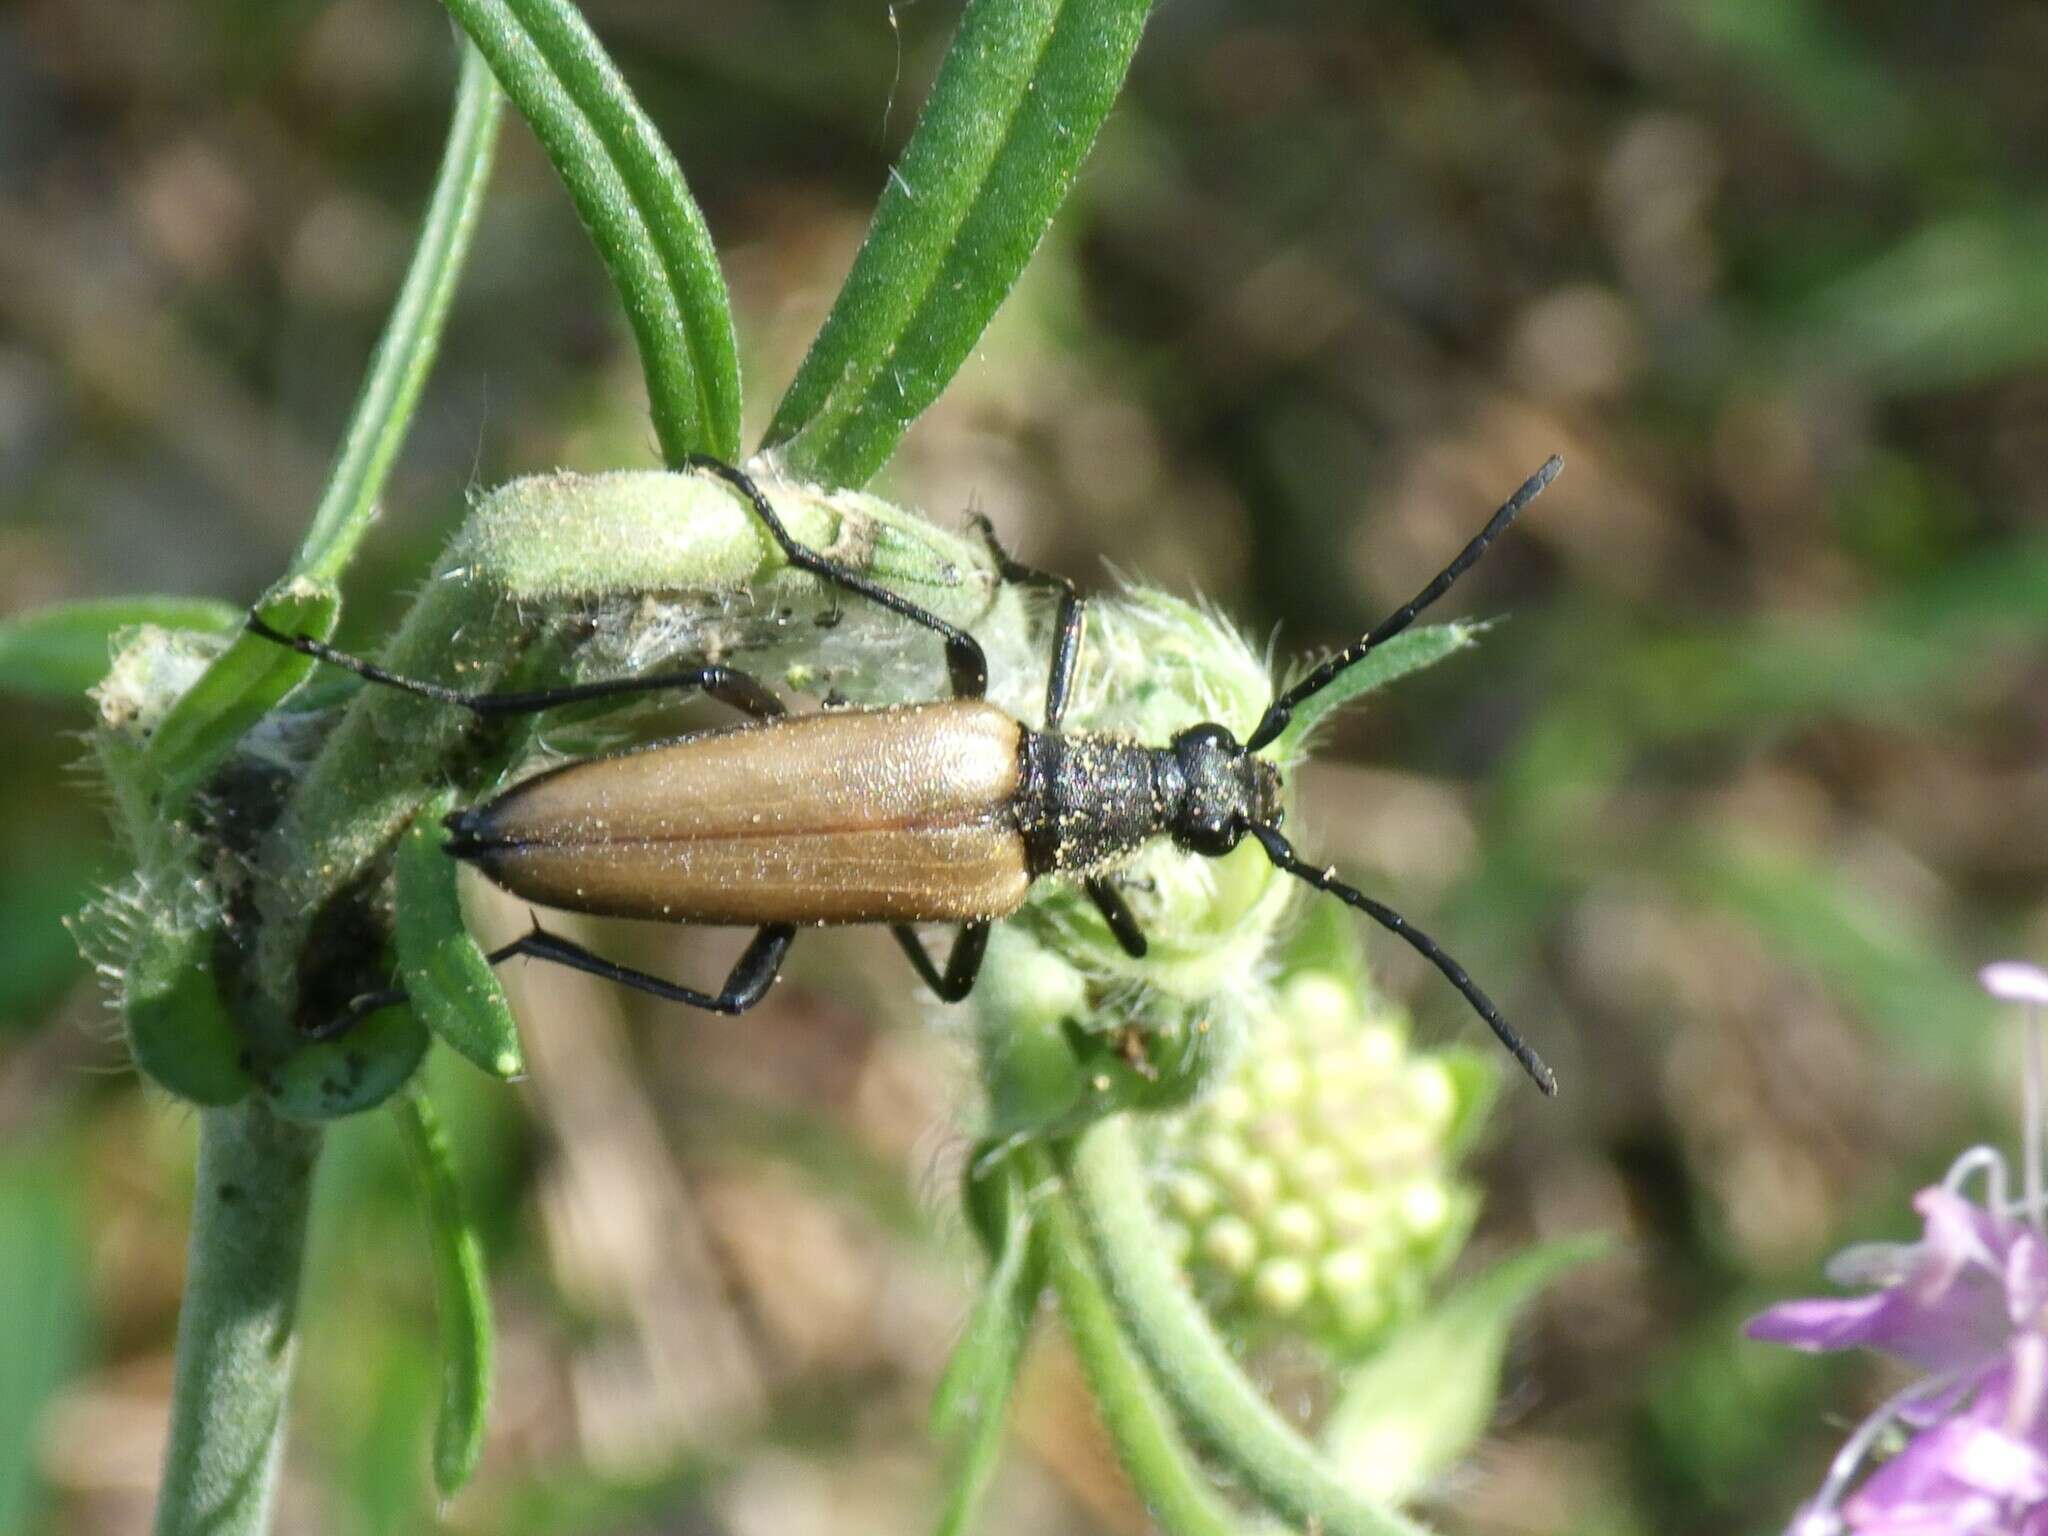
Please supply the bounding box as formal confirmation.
[1323,1237,1608,1503]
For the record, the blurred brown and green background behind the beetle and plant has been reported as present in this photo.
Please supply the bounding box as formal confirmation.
[0,0,2048,1536]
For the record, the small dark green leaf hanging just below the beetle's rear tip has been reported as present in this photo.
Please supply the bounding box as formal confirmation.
[395,791,526,1079]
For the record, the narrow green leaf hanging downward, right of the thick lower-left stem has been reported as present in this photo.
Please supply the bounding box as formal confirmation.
[391,1094,492,1499]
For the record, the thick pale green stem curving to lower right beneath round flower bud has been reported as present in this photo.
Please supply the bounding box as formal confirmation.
[1055,1116,1423,1536]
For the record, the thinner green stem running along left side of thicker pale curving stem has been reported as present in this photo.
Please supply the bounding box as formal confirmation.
[1018,1147,1239,1536]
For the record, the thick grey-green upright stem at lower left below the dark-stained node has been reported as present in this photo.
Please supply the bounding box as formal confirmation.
[156,1102,319,1536]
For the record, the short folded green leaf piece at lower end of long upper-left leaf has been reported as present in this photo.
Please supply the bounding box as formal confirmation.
[145,575,342,819]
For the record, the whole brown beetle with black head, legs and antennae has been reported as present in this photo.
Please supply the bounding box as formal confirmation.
[250,459,1563,1094]
